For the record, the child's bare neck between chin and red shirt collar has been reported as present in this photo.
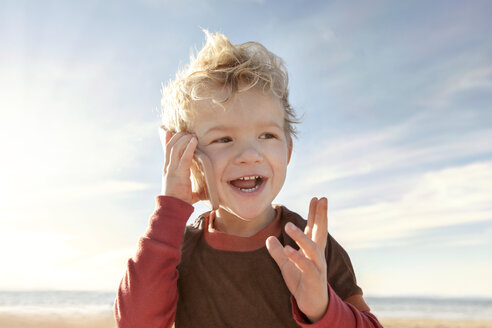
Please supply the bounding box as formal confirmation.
[214,206,276,237]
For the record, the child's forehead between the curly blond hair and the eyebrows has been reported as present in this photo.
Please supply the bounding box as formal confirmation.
[191,88,285,134]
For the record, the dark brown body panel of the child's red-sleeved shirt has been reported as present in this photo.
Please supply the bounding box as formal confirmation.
[176,207,362,328]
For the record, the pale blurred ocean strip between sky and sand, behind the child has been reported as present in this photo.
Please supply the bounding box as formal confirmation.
[0,291,492,320]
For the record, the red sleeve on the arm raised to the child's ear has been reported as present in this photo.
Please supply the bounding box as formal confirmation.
[114,196,193,328]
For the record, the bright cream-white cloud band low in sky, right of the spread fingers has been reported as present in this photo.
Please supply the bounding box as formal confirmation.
[333,162,492,247]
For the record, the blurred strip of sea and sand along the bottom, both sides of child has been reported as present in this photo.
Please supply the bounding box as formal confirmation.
[0,291,492,328]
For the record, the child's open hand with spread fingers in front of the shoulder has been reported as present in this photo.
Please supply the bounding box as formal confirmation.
[266,198,328,323]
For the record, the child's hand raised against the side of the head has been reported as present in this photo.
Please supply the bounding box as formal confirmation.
[159,128,200,205]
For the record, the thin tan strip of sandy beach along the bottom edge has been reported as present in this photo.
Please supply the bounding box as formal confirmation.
[0,314,492,328]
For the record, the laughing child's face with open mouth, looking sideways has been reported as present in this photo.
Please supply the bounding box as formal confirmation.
[192,88,291,221]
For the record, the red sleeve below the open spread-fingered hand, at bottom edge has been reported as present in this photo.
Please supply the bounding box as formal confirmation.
[291,285,383,328]
